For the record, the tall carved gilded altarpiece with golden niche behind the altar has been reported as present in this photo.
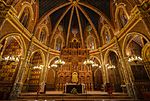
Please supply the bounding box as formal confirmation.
[56,42,93,91]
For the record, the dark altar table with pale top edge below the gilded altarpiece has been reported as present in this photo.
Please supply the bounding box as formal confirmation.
[65,83,85,93]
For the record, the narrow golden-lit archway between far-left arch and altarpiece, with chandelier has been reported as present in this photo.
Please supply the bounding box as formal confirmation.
[26,51,44,92]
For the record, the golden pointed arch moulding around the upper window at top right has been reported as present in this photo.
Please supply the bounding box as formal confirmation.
[115,3,129,29]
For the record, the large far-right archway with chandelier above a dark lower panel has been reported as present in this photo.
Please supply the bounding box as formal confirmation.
[125,34,149,81]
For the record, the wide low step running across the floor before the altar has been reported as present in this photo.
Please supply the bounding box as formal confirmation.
[18,93,132,100]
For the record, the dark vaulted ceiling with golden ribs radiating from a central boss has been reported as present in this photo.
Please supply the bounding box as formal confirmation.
[39,0,110,47]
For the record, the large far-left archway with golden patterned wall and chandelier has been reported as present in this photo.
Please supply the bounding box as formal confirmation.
[0,35,24,99]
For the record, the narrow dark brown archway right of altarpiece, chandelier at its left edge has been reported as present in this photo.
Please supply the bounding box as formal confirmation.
[106,51,123,92]
